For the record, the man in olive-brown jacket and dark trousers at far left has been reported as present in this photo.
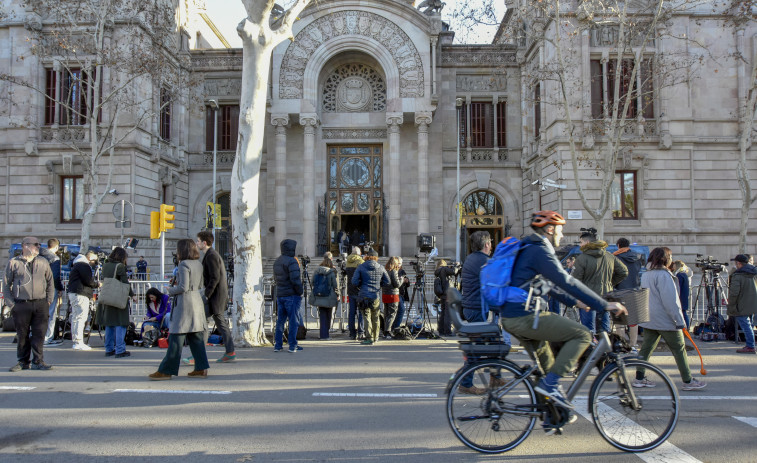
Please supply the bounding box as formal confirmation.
[3,236,55,372]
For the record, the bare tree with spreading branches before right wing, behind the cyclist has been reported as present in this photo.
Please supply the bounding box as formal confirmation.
[503,0,702,236]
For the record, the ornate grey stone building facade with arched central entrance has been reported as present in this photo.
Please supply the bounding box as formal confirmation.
[0,0,757,270]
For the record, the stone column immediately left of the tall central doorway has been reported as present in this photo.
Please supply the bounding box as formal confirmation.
[297,113,318,257]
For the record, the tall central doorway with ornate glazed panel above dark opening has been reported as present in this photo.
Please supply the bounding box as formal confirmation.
[326,145,384,253]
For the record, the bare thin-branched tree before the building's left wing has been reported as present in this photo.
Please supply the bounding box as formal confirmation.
[0,0,188,249]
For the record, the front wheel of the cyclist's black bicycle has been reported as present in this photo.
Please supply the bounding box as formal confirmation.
[589,359,680,452]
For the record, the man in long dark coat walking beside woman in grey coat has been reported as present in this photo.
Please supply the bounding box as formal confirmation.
[197,231,230,363]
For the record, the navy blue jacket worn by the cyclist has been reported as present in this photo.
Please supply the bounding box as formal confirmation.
[501,233,607,318]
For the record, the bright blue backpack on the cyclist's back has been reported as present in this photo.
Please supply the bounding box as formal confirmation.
[480,237,528,318]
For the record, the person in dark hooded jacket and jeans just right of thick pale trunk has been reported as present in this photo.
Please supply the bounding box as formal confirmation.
[273,239,302,354]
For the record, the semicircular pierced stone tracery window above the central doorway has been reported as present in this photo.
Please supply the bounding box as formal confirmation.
[322,64,386,113]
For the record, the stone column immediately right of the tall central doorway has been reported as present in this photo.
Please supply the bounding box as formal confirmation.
[384,112,403,256]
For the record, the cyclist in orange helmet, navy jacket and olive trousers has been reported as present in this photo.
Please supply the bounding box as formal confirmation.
[500,211,626,409]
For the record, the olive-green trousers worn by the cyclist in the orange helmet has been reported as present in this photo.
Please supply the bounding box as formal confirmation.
[501,312,591,377]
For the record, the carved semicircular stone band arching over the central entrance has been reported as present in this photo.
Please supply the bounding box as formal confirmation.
[279,11,424,99]
